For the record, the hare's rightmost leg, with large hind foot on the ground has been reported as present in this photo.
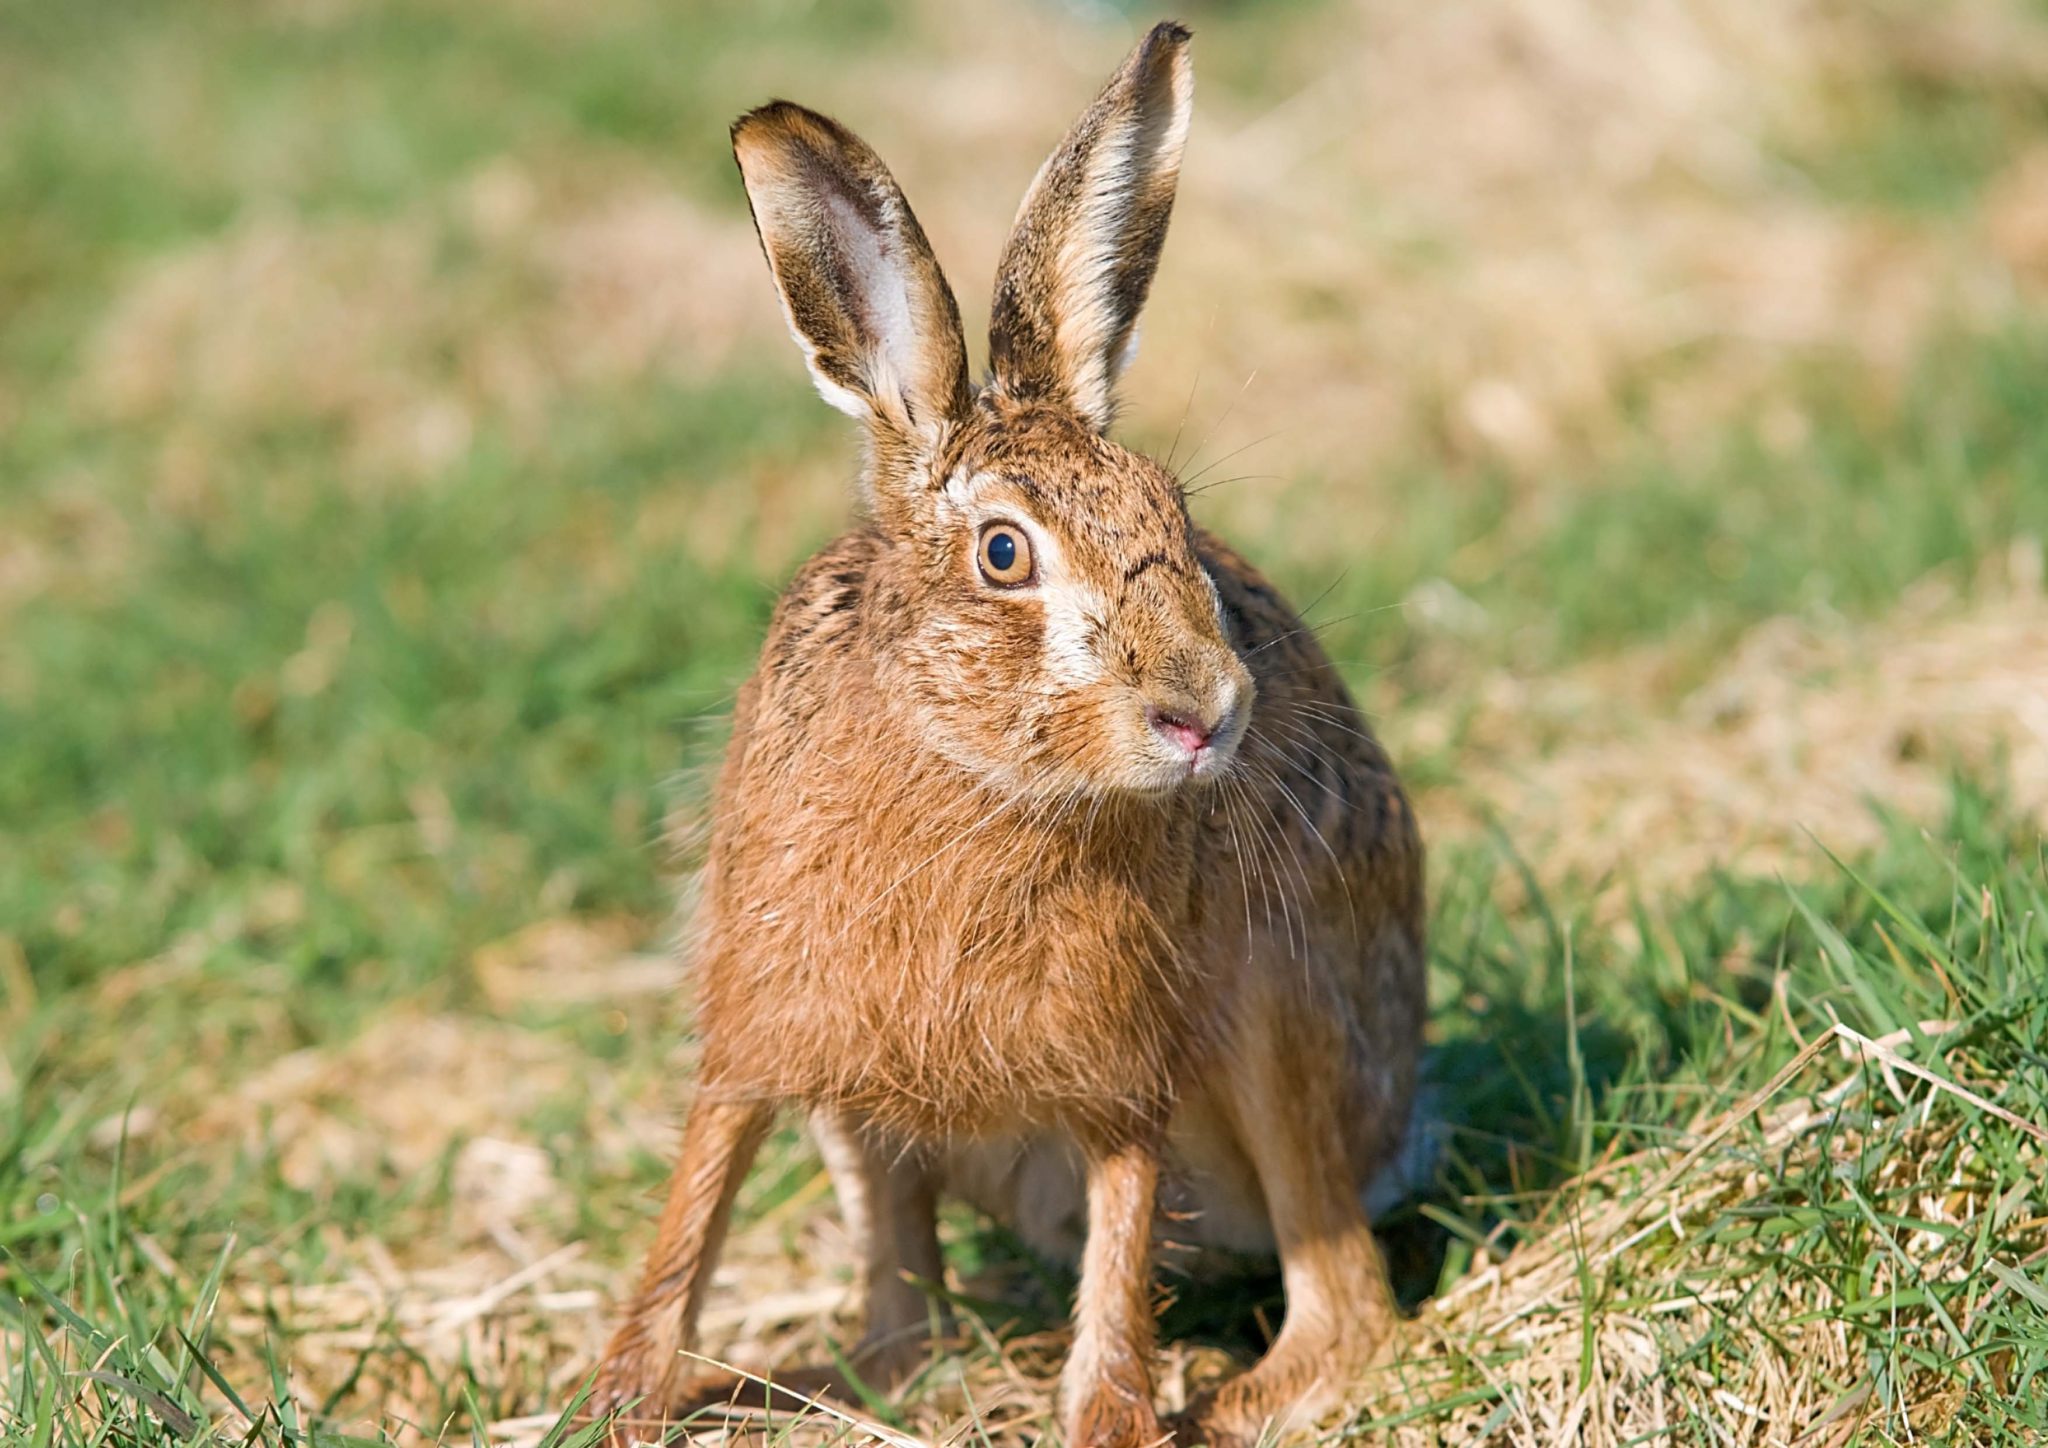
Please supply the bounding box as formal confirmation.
[1176,961,1399,1448]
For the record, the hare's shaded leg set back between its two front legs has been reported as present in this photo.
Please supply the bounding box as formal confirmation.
[811,1112,946,1389]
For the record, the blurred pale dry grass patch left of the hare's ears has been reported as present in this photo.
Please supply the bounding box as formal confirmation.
[82,175,780,487]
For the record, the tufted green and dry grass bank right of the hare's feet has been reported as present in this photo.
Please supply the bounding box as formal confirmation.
[1359,789,2048,1442]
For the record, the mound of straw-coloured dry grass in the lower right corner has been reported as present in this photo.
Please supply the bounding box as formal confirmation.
[1364,1022,2048,1446]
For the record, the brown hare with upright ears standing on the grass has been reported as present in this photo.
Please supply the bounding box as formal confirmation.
[594,23,1423,1448]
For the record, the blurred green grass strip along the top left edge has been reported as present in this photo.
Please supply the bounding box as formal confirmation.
[0,0,891,334]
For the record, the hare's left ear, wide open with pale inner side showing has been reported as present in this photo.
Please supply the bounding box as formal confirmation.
[733,100,969,442]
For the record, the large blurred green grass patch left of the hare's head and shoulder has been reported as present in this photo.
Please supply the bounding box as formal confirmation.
[0,383,831,985]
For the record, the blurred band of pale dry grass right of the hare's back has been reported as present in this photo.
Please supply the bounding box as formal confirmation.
[1395,541,2048,893]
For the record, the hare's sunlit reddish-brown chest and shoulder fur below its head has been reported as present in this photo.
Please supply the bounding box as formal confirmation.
[698,535,1200,1141]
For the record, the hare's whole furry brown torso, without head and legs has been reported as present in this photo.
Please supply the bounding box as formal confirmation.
[696,501,1421,1169]
